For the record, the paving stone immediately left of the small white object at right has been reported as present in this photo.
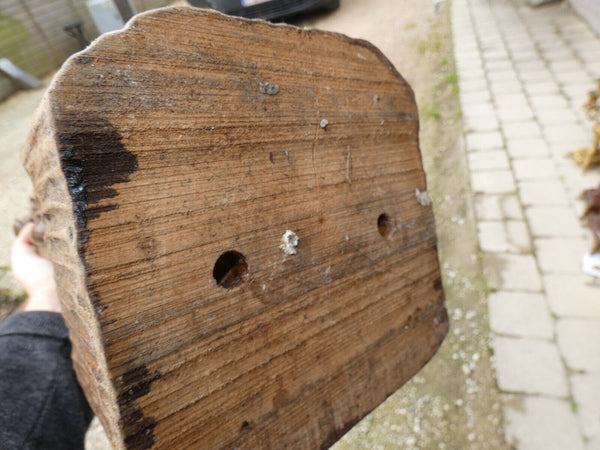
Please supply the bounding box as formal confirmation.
[533,237,589,274]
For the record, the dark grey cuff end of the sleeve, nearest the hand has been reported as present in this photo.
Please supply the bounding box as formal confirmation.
[0,311,69,339]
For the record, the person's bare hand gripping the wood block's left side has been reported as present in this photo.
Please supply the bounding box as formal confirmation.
[12,222,62,312]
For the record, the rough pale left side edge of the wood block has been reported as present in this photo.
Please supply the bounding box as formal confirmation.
[21,93,123,448]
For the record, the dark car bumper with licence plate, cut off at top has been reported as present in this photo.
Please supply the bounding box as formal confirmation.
[188,0,340,20]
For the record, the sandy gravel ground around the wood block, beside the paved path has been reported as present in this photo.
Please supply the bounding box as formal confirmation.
[0,0,507,450]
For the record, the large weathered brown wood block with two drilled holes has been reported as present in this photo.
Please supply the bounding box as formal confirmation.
[23,8,448,449]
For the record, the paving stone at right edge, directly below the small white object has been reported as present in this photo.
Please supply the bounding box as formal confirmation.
[543,274,600,316]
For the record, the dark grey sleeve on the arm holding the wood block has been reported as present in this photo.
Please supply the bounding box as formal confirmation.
[0,311,93,449]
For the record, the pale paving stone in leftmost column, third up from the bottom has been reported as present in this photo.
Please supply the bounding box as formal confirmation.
[488,291,554,339]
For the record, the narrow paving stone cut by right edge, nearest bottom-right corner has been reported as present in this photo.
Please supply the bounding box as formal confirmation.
[570,373,600,443]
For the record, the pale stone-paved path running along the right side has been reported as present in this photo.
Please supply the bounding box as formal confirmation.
[452,0,600,450]
